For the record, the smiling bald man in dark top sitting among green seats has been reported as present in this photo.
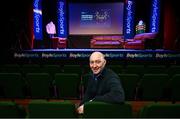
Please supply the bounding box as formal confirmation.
[77,52,125,114]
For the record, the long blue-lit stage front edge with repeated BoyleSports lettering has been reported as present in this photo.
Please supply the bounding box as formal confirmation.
[13,49,180,60]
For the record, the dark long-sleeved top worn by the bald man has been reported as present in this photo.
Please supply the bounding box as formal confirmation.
[80,68,125,105]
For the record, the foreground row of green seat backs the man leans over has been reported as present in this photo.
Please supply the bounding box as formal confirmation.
[0,100,180,118]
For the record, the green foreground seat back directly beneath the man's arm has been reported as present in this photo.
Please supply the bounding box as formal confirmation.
[83,101,132,118]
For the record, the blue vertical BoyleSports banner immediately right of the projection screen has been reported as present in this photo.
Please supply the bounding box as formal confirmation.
[124,0,134,39]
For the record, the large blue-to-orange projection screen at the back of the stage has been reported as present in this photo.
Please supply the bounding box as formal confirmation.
[69,2,124,35]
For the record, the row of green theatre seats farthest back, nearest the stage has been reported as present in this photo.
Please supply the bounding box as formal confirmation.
[0,63,180,76]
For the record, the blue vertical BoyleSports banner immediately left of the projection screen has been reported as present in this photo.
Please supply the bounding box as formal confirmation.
[57,0,67,38]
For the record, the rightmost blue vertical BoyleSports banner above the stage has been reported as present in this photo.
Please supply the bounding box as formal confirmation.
[150,0,160,33]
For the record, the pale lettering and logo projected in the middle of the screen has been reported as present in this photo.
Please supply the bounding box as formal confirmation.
[80,9,111,27]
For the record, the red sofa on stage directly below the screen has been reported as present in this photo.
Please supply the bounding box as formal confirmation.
[90,36,124,48]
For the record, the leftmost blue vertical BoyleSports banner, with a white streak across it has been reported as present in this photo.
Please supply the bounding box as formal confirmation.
[33,0,42,40]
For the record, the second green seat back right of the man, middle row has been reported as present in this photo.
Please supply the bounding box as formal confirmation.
[138,74,169,101]
